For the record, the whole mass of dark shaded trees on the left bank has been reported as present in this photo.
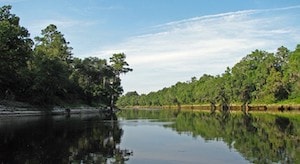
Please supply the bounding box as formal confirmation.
[0,6,131,106]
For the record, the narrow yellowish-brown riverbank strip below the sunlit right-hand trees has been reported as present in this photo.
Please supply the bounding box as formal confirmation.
[122,104,300,112]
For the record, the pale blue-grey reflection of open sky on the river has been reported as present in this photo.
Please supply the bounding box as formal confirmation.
[120,120,249,164]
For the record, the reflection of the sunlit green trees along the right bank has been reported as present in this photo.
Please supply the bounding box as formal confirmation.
[122,111,300,163]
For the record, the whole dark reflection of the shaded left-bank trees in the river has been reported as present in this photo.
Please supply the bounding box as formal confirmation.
[0,114,131,163]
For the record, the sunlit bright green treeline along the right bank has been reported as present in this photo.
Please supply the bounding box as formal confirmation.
[117,45,300,106]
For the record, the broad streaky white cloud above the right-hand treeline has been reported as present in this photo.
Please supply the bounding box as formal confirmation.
[92,6,300,93]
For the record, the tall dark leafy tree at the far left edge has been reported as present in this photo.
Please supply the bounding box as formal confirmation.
[0,6,33,99]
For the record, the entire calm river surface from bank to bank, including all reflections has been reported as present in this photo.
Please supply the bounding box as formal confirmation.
[0,110,300,164]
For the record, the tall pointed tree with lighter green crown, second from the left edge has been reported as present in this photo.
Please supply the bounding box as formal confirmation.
[30,24,71,104]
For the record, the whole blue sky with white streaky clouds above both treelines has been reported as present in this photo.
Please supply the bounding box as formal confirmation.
[0,0,300,93]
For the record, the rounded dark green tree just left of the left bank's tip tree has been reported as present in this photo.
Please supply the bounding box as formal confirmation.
[70,57,117,105]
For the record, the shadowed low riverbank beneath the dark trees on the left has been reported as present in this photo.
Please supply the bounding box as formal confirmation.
[0,100,108,117]
